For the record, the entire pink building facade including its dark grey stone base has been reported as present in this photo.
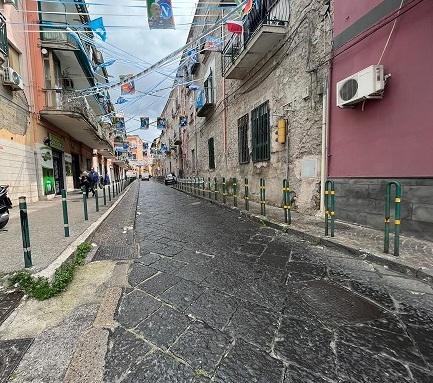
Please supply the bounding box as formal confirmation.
[328,0,433,240]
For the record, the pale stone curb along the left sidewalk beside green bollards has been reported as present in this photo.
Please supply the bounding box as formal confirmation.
[34,182,134,279]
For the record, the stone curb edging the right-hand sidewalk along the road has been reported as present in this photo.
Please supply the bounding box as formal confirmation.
[172,187,433,285]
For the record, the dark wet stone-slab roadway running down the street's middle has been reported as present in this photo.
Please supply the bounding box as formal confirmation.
[104,182,433,383]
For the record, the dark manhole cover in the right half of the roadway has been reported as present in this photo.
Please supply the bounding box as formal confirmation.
[301,281,383,324]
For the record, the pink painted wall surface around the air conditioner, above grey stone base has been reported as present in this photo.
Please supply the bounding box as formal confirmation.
[328,0,433,178]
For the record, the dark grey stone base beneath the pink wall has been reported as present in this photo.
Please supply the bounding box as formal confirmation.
[334,179,433,241]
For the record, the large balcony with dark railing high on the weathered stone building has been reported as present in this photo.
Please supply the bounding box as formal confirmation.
[223,0,290,80]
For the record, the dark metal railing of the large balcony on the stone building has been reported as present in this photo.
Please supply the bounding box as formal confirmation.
[223,0,290,78]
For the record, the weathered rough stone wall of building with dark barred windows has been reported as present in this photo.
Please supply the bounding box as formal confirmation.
[181,0,331,212]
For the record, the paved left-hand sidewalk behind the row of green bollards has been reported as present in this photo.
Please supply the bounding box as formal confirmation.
[0,184,130,275]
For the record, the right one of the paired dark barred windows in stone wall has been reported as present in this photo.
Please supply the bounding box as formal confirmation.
[251,102,271,162]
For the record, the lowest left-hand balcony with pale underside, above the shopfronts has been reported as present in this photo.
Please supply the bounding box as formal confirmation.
[40,89,113,156]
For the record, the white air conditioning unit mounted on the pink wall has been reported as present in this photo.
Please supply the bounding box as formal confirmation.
[337,65,385,108]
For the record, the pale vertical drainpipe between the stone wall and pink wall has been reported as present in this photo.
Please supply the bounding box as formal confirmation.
[320,75,331,213]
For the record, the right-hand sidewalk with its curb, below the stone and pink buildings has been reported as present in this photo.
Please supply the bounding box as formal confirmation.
[173,186,433,283]
